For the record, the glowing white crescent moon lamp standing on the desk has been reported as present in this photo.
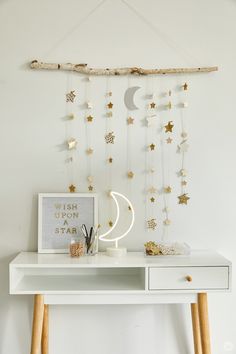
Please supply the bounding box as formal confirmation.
[99,191,134,257]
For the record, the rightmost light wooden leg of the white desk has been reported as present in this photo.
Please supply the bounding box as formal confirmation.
[198,293,211,354]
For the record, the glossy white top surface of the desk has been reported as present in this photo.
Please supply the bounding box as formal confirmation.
[11,250,231,268]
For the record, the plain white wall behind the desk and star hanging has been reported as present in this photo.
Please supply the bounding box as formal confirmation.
[0,0,236,354]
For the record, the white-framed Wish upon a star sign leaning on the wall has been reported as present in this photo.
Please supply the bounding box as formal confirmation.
[38,193,98,253]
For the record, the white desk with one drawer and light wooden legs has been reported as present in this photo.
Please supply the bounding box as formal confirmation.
[10,251,231,354]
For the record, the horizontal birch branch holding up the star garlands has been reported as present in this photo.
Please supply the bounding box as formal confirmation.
[30,60,218,75]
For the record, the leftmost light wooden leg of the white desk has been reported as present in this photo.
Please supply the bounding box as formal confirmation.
[31,295,44,354]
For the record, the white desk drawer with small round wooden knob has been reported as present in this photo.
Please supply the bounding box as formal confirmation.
[149,266,229,290]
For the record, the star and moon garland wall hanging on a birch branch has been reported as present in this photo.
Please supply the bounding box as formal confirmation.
[30,0,218,252]
